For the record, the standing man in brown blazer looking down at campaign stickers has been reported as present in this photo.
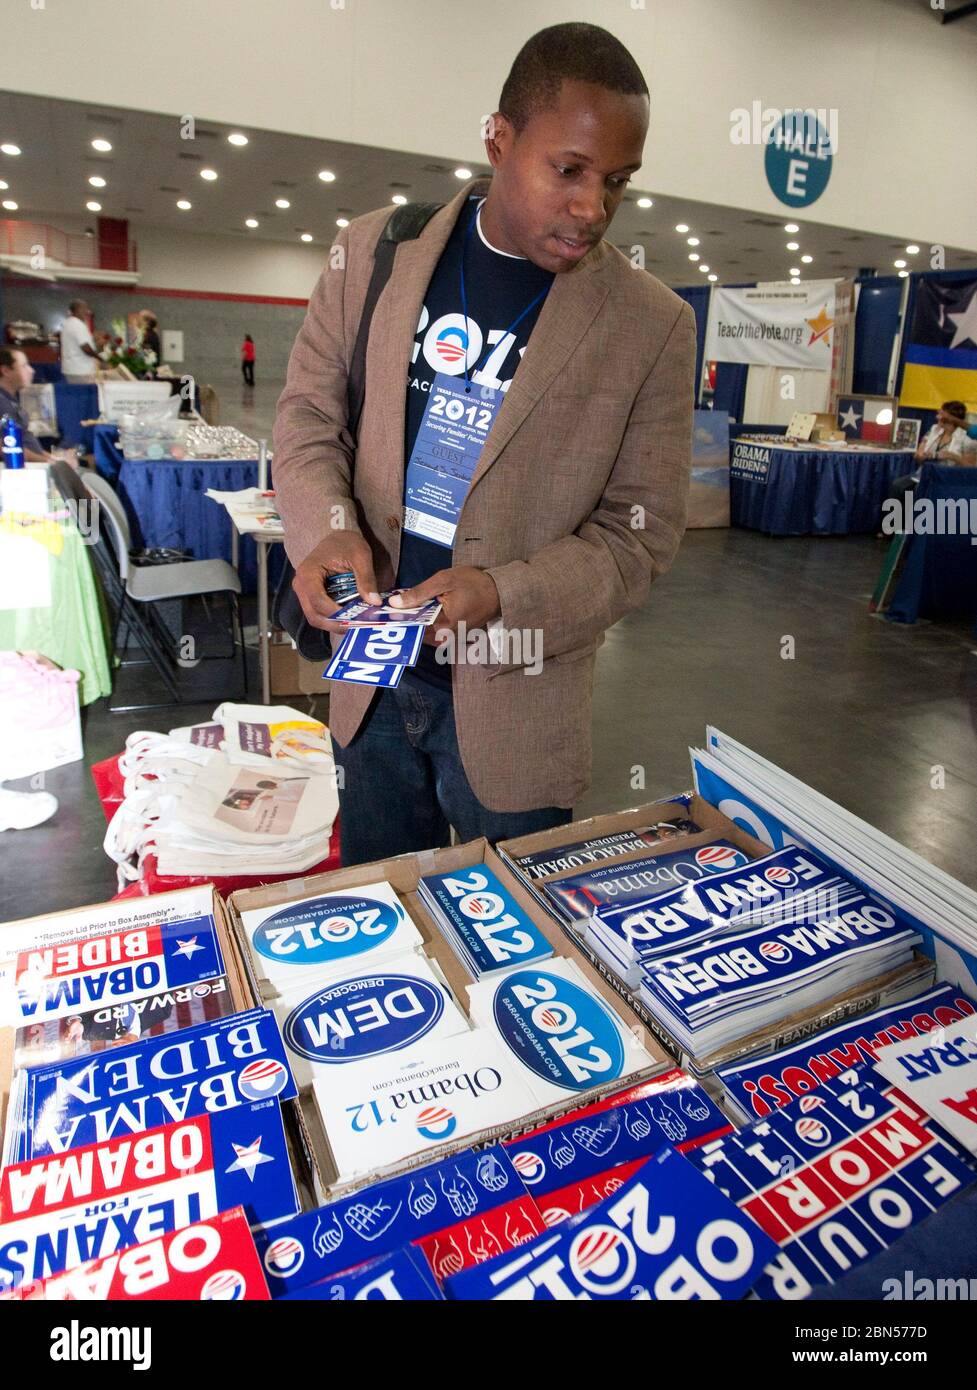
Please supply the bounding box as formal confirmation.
[274,24,695,863]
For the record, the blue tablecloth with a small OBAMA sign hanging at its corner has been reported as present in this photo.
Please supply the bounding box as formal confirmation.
[730,439,914,535]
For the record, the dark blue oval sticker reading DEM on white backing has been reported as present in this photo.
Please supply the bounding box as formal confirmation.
[284,974,445,1063]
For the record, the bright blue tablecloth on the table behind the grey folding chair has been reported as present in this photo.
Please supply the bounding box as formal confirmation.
[115,459,282,594]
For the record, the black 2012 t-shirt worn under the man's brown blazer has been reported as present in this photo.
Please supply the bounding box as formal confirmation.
[397,196,553,687]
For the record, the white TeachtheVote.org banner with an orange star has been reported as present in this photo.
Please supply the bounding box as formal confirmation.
[705,279,834,371]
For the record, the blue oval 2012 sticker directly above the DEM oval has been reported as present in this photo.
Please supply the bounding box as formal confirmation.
[252,894,404,969]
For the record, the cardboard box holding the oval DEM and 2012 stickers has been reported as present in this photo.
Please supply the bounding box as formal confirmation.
[228,840,673,1202]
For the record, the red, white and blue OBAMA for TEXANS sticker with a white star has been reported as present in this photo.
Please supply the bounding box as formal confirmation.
[0,1105,296,1287]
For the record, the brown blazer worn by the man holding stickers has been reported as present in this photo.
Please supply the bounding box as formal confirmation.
[274,181,695,810]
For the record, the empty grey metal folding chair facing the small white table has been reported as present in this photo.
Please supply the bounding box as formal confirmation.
[82,471,247,712]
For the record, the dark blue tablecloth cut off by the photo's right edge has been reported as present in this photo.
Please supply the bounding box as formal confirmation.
[885,463,977,623]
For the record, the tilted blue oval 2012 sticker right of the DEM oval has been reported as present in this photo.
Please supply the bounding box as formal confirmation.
[492,970,624,1091]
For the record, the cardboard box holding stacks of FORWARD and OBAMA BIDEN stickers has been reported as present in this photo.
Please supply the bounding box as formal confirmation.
[495,792,924,1078]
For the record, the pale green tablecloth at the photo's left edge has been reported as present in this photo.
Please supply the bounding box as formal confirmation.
[0,520,113,705]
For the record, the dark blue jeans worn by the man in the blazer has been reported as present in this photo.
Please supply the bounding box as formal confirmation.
[335,671,573,866]
